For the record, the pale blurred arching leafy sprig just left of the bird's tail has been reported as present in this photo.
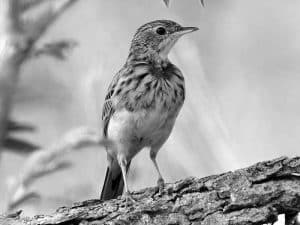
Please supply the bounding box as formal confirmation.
[7,127,111,210]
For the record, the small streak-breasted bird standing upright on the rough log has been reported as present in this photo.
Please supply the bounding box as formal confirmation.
[100,20,198,201]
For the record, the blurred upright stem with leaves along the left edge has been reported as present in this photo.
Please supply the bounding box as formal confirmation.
[0,0,77,156]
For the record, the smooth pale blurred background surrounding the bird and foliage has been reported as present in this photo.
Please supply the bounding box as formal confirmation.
[0,0,300,215]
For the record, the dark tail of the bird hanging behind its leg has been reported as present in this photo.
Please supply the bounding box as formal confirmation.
[100,161,130,201]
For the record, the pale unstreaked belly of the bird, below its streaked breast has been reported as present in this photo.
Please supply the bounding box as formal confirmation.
[108,108,177,157]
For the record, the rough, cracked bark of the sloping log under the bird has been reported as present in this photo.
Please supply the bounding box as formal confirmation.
[1,157,300,225]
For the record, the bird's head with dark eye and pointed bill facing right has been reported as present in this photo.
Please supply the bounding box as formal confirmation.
[130,20,198,59]
